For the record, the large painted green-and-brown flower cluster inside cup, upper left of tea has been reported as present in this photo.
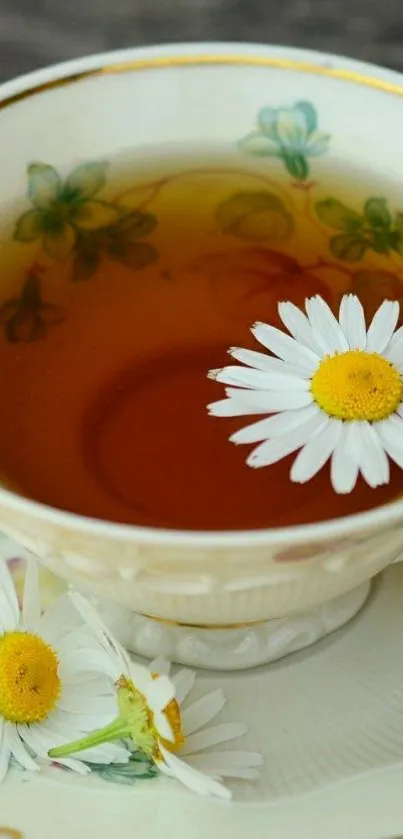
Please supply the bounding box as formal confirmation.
[14,161,158,280]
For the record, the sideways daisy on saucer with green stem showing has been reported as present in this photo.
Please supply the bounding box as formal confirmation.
[49,593,263,798]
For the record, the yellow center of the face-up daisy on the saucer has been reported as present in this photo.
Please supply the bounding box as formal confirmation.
[0,632,60,723]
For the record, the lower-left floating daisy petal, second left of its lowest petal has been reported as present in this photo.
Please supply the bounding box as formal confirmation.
[246,409,328,469]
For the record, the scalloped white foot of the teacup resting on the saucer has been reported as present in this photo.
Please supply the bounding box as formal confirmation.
[104,582,370,670]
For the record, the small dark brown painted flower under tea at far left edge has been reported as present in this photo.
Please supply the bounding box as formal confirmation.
[0,268,65,344]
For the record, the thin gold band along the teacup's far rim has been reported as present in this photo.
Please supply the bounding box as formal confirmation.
[0,54,403,109]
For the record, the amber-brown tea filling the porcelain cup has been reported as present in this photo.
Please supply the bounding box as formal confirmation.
[0,152,403,530]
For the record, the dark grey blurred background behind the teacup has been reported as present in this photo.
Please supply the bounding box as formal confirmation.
[0,0,403,81]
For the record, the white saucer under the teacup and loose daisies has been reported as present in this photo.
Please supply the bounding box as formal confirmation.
[0,542,403,839]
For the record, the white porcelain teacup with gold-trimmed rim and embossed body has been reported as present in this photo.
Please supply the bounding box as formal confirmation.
[0,44,403,669]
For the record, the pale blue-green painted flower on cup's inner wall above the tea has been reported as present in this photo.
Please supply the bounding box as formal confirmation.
[239,102,330,181]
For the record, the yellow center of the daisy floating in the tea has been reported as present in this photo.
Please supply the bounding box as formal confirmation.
[311,350,402,422]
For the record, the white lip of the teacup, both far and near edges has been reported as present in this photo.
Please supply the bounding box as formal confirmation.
[0,41,403,549]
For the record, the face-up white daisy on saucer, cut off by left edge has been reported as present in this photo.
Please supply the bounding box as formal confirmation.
[0,560,129,781]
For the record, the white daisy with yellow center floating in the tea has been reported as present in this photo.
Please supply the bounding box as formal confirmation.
[208,294,403,493]
